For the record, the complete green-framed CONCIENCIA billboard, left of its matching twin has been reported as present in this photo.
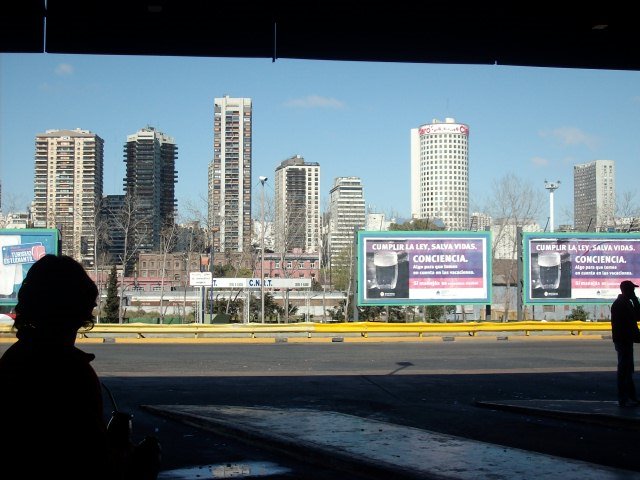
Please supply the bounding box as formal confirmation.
[357,231,491,306]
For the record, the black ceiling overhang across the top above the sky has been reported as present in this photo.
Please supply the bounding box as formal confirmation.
[0,0,640,70]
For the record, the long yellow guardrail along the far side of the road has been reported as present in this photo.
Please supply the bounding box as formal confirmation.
[0,321,611,339]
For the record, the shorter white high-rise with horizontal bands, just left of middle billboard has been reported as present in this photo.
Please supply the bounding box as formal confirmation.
[329,177,366,267]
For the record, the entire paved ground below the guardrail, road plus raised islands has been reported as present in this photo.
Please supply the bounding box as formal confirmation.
[0,337,640,480]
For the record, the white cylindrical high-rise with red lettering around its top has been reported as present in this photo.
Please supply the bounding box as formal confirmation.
[411,118,469,230]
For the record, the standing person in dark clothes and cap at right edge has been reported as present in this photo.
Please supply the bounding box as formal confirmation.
[611,280,640,407]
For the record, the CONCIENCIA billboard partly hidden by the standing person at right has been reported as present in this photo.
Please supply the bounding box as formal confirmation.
[523,233,640,304]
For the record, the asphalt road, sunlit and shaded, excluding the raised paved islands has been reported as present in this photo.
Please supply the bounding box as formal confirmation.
[0,336,640,479]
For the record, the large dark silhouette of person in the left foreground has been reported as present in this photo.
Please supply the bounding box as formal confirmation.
[0,255,157,480]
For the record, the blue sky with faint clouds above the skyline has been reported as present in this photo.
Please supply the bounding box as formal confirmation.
[0,53,640,227]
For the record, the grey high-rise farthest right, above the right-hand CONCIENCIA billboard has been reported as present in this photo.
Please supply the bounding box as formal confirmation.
[573,160,616,232]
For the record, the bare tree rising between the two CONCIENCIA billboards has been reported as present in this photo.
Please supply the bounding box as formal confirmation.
[490,173,544,321]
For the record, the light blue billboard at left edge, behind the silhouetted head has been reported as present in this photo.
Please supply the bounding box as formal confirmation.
[0,228,60,306]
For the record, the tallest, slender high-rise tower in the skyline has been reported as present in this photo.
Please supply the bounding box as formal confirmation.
[208,95,253,261]
